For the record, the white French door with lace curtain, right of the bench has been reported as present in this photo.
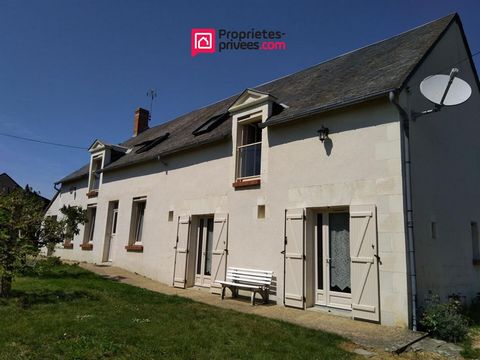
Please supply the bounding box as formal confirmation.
[315,210,352,310]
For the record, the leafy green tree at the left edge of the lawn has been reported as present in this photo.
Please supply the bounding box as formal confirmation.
[0,186,86,297]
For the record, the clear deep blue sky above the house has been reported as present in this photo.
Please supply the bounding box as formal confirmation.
[0,0,480,197]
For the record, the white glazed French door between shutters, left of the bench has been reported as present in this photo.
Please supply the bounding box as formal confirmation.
[195,217,213,287]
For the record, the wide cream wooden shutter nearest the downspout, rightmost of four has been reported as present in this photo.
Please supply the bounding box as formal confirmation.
[350,205,380,321]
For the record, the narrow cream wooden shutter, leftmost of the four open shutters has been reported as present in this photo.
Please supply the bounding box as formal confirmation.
[173,215,190,288]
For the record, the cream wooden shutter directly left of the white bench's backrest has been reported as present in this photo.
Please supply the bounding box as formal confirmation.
[210,214,228,294]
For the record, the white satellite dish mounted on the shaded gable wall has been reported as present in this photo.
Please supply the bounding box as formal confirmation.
[413,68,472,119]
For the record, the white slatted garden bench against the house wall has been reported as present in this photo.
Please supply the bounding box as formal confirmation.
[217,267,273,305]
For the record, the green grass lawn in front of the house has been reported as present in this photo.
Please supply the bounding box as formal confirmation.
[0,265,351,360]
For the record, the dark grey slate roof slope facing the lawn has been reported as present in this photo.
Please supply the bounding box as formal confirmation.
[58,14,458,183]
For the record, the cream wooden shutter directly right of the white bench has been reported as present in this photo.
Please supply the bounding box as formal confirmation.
[284,209,305,309]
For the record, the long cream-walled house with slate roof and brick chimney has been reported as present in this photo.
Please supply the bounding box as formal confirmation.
[48,14,480,328]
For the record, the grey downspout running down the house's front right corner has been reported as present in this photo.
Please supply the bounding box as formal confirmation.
[389,91,417,331]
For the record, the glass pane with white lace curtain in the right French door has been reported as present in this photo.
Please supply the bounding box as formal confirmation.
[329,213,351,293]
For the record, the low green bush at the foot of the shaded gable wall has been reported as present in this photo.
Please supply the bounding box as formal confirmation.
[420,295,468,342]
